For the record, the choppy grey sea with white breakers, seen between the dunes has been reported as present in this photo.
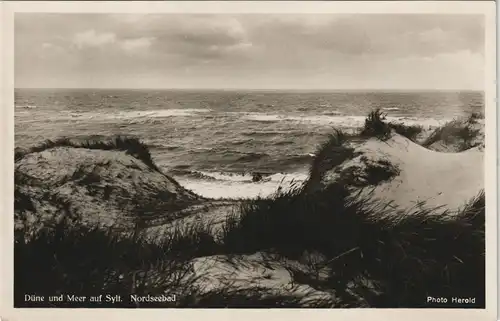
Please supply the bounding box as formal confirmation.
[15,89,484,198]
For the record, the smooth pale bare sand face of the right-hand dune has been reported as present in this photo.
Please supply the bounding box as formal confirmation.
[321,134,484,210]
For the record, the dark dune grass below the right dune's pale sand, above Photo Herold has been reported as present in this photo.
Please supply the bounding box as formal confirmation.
[219,186,485,308]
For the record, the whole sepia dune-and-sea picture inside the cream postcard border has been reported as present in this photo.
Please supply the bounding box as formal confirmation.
[1,1,496,318]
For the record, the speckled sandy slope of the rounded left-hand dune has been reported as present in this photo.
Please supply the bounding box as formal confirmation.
[15,147,201,232]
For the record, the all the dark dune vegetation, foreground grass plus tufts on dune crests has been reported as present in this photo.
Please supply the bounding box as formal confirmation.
[14,111,485,308]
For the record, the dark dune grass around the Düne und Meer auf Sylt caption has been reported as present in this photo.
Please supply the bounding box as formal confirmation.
[14,210,331,308]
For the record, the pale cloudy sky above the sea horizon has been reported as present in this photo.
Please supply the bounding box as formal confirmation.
[14,13,485,90]
